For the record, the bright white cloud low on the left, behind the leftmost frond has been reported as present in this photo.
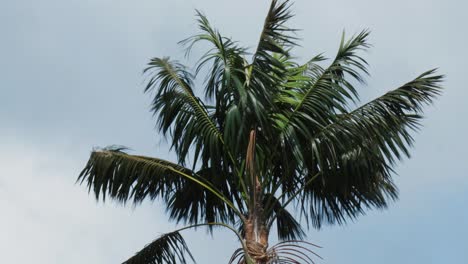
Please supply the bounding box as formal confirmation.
[0,137,174,264]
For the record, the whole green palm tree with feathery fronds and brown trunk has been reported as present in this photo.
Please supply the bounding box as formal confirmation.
[78,0,443,263]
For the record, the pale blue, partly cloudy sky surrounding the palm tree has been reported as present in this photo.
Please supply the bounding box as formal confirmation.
[0,0,468,264]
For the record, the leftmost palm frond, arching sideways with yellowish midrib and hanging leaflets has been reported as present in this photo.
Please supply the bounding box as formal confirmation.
[77,148,241,219]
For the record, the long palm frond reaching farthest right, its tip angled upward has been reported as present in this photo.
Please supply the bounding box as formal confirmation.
[312,70,443,163]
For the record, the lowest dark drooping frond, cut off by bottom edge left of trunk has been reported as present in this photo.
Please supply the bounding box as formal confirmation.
[123,231,195,264]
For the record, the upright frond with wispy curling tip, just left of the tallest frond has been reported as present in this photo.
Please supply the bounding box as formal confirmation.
[181,11,247,155]
